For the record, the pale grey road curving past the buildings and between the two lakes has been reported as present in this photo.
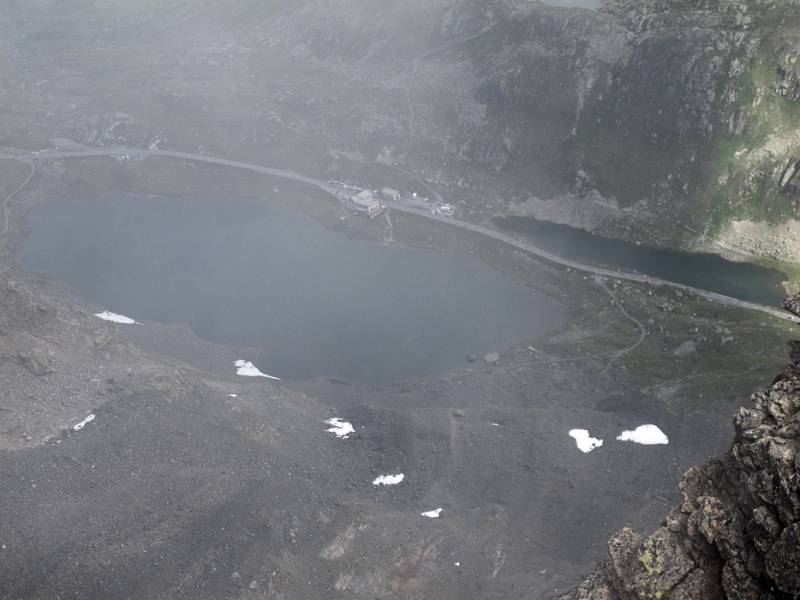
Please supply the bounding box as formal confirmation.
[0,146,800,323]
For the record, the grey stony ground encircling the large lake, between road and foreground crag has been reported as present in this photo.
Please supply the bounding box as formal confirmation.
[0,152,788,599]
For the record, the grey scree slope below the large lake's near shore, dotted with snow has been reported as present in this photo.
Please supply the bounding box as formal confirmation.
[0,264,736,598]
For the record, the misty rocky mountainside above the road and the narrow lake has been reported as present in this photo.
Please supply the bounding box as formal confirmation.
[0,0,800,261]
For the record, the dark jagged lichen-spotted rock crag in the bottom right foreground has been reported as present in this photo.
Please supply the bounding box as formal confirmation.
[561,343,800,600]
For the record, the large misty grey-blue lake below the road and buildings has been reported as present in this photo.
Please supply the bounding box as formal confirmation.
[19,197,564,381]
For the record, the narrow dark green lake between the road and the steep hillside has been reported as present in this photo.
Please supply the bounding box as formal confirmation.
[494,217,787,307]
